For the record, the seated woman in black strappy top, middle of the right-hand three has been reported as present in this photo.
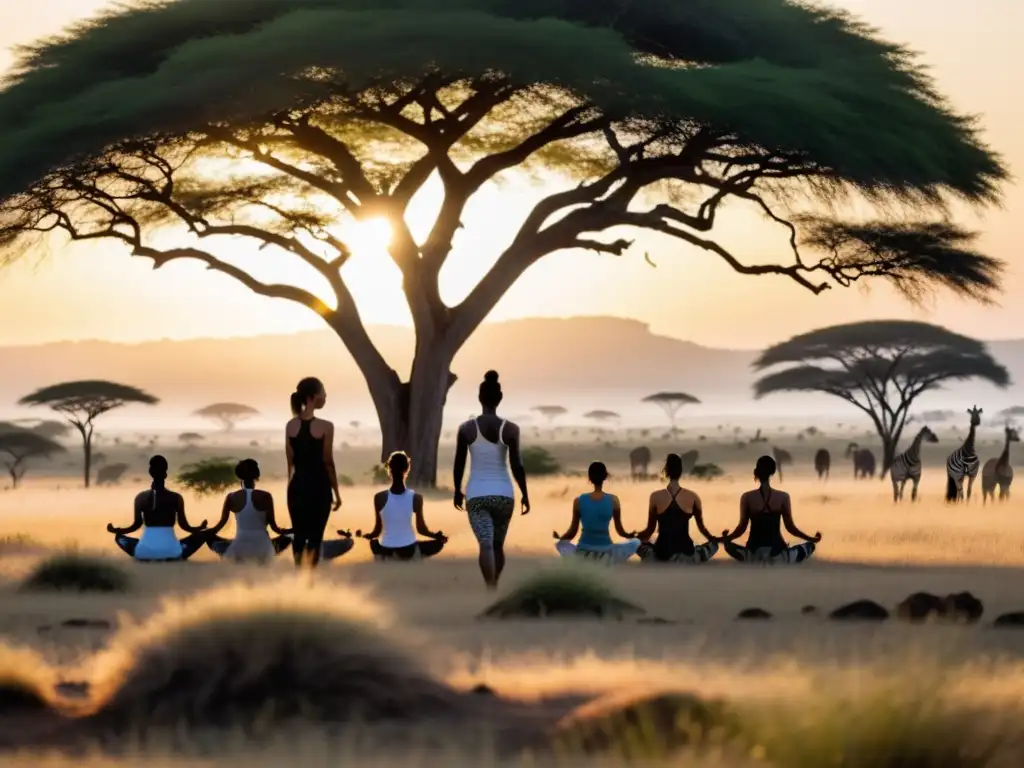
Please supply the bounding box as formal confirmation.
[634,454,718,563]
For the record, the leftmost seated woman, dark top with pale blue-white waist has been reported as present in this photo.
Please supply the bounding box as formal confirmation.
[106,456,207,562]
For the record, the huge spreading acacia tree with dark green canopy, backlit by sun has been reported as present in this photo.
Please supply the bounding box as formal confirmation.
[0,0,1006,483]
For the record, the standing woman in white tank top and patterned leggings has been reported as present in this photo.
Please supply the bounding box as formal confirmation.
[455,371,529,589]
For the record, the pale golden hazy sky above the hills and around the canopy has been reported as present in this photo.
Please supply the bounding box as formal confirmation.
[0,0,1024,347]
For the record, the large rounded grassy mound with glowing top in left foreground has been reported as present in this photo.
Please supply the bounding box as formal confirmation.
[92,578,464,732]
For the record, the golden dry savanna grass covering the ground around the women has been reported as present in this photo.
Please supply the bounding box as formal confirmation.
[0,441,1024,768]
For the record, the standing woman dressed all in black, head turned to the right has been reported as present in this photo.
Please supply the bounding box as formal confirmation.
[285,377,342,567]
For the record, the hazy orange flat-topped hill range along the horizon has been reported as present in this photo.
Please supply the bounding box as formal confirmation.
[0,317,1024,429]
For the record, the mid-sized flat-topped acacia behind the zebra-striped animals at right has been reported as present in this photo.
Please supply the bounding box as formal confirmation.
[754,321,1010,477]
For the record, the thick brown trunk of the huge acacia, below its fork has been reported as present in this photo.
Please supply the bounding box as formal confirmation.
[365,343,456,488]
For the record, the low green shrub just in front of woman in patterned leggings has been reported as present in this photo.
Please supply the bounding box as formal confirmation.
[482,563,645,618]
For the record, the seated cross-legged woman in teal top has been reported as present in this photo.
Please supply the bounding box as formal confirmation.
[554,462,640,562]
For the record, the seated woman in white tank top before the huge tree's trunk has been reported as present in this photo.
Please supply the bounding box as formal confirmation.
[360,451,447,560]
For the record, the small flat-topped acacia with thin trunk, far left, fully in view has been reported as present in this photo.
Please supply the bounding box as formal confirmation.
[18,380,160,487]
